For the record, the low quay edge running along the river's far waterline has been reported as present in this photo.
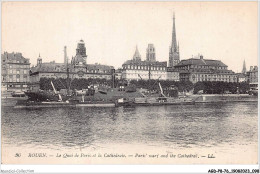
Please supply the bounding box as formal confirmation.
[1,94,258,108]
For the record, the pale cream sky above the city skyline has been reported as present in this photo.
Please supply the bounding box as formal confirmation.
[1,2,258,72]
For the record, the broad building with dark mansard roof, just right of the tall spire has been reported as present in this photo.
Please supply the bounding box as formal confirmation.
[175,55,237,83]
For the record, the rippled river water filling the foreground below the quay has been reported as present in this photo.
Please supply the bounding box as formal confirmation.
[2,102,258,164]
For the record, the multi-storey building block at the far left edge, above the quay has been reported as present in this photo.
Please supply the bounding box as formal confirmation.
[1,52,30,92]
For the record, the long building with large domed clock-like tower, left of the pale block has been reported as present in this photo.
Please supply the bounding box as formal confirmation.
[30,40,114,90]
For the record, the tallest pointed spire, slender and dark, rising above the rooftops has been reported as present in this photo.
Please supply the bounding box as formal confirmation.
[169,13,180,67]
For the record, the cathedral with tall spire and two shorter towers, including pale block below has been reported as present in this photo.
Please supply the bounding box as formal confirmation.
[122,15,180,81]
